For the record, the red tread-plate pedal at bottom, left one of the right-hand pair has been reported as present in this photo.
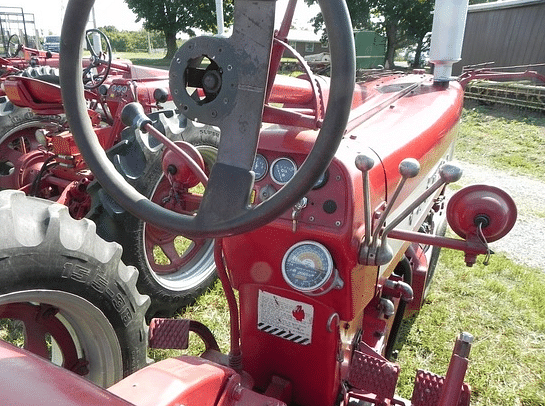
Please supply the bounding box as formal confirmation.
[348,351,399,400]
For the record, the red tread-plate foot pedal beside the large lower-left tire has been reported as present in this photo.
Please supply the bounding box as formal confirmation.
[149,318,191,350]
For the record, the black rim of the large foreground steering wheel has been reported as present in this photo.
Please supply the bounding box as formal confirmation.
[60,0,355,238]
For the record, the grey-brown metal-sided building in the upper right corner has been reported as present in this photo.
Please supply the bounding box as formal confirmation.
[453,0,545,75]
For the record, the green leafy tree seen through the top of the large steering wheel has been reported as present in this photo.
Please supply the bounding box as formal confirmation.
[125,0,233,59]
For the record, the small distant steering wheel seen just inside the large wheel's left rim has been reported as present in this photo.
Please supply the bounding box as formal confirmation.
[82,28,112,89]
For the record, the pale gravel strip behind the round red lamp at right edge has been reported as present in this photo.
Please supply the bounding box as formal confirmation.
[448,162,545,272]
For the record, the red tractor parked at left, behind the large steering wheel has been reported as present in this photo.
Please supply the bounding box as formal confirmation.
[0,25,223,326]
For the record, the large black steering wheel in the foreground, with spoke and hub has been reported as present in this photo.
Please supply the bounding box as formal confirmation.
[60,0,355,238]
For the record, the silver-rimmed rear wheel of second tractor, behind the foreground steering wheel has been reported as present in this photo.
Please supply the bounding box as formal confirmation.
[90,113,220,320]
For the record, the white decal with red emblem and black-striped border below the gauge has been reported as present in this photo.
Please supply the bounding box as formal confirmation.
[257,290,314,345]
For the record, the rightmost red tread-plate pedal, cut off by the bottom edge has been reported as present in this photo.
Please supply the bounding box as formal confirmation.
[411,370,471,406]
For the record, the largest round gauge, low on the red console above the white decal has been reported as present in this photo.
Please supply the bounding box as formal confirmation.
[282,241,334,293]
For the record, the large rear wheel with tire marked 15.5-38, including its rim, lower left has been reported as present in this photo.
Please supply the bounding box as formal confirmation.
[0,190,149,387]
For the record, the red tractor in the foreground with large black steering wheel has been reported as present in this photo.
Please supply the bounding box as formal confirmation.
[0,0,516,406]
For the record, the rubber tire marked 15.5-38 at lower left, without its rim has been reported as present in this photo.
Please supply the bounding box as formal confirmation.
[0,191,149,384]
